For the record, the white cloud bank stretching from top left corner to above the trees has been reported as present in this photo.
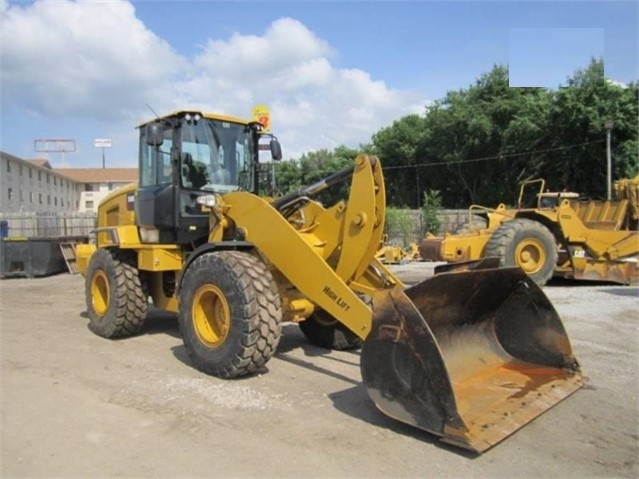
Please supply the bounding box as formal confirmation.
[0,0,425,163]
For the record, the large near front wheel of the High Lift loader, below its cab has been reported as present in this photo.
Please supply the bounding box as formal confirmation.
[178,251,282,378]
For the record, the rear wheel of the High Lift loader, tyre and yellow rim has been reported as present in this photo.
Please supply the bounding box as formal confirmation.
[85,249,148,339]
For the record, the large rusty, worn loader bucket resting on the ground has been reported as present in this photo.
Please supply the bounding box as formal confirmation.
[360,268,585,452]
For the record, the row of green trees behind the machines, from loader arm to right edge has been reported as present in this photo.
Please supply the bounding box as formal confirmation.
[276,59,639,209]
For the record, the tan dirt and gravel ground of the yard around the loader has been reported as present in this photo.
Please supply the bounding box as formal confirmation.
[0,263,639,478]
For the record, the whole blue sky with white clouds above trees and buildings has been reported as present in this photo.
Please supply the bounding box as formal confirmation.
[0,0,639,168]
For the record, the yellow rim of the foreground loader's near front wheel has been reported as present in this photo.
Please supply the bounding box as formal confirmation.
[191,284,231,348]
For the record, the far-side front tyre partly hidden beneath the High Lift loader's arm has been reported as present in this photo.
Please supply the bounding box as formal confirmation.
[299,309,362,351]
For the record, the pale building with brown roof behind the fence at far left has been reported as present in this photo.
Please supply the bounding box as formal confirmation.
[0,151,138,213]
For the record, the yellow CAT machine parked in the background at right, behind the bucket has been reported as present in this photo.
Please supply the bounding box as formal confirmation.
[419,177,639,286]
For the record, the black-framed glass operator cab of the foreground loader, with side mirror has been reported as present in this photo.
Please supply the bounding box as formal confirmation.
[135,111,282,245]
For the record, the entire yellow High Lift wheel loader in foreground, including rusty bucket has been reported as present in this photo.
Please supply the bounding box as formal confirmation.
[76,111,584,452]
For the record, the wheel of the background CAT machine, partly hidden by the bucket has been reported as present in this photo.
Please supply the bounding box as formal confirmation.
[484,218,557,286]
